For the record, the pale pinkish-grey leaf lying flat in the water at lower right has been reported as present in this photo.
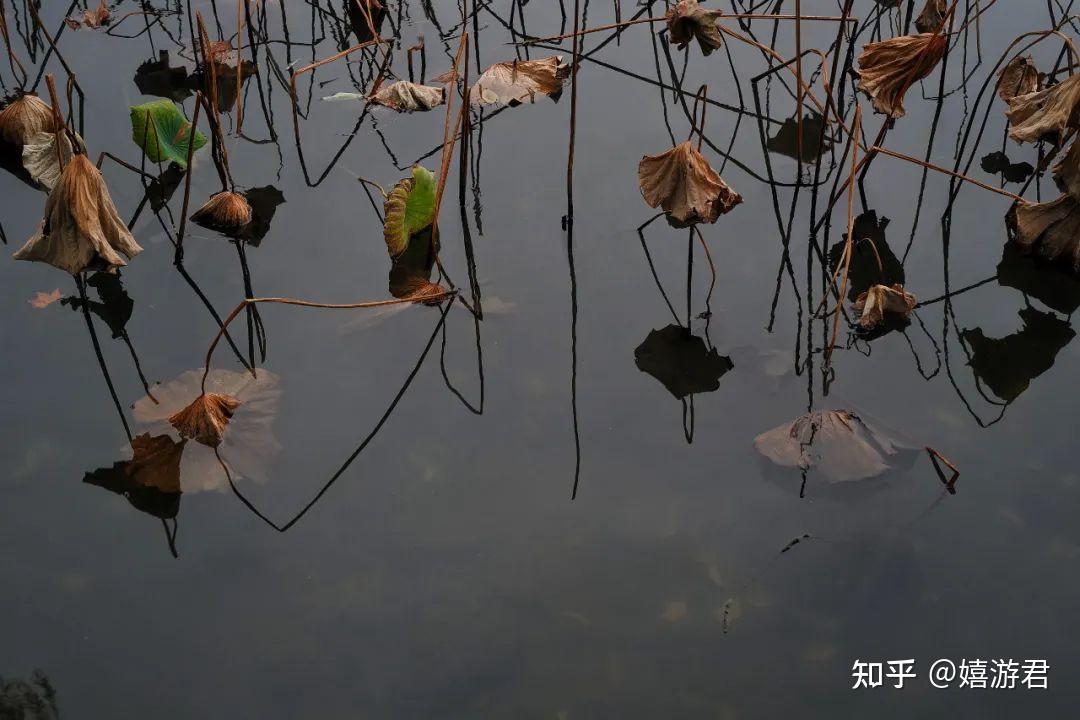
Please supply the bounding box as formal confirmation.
[754,410,913,483]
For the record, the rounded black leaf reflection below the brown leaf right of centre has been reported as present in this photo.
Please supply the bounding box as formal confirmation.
[634,325,734,399]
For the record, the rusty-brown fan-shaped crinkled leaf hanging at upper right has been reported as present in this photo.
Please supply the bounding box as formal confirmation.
[858,32,948,118]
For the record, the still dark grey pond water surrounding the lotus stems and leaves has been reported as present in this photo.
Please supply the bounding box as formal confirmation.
[0,0,1080,719]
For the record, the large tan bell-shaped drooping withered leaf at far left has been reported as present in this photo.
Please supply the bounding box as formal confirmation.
[14,155,143,275]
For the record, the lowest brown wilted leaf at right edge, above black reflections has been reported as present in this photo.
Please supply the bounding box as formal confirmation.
[1007,194,1080,273]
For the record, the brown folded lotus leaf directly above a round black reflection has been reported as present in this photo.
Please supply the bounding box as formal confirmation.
[637,140,742,226]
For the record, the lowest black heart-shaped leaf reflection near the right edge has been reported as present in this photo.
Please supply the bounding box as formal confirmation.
[960,308,1076,403]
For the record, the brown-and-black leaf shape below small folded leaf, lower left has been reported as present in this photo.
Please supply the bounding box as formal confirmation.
[82,433,186,519]
